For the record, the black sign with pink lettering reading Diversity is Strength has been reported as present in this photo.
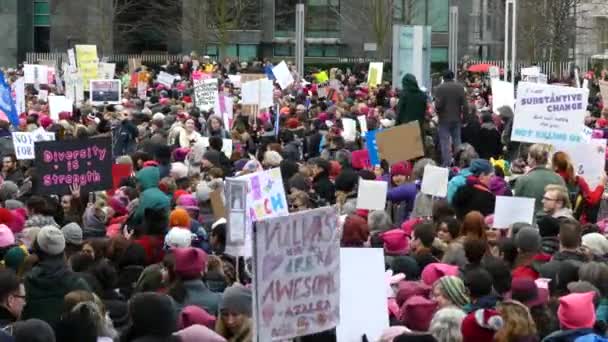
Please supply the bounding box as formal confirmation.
[34,137,112,195]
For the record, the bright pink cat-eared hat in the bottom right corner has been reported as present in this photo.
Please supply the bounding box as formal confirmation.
[557,292,595,329]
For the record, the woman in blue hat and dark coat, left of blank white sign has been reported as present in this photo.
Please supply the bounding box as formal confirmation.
[452,159,496,218]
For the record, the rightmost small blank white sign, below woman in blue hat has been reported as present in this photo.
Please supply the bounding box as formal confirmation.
[493,196,535,229]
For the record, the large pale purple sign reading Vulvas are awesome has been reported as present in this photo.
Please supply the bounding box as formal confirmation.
[254,207,342,341]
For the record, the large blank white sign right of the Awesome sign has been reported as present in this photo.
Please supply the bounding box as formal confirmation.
[336,248,389,342]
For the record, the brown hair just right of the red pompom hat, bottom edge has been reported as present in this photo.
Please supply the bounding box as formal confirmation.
[494,300,537,342]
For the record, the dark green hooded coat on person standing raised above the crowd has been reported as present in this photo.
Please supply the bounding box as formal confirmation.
[396,74,427,127]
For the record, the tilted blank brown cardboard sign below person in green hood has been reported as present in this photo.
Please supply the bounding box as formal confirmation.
[370,121,424,164]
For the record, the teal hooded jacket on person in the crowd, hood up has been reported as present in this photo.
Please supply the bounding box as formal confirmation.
[133,166,171,224]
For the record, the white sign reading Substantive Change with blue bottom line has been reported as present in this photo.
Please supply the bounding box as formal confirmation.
[511,82,589,144]
